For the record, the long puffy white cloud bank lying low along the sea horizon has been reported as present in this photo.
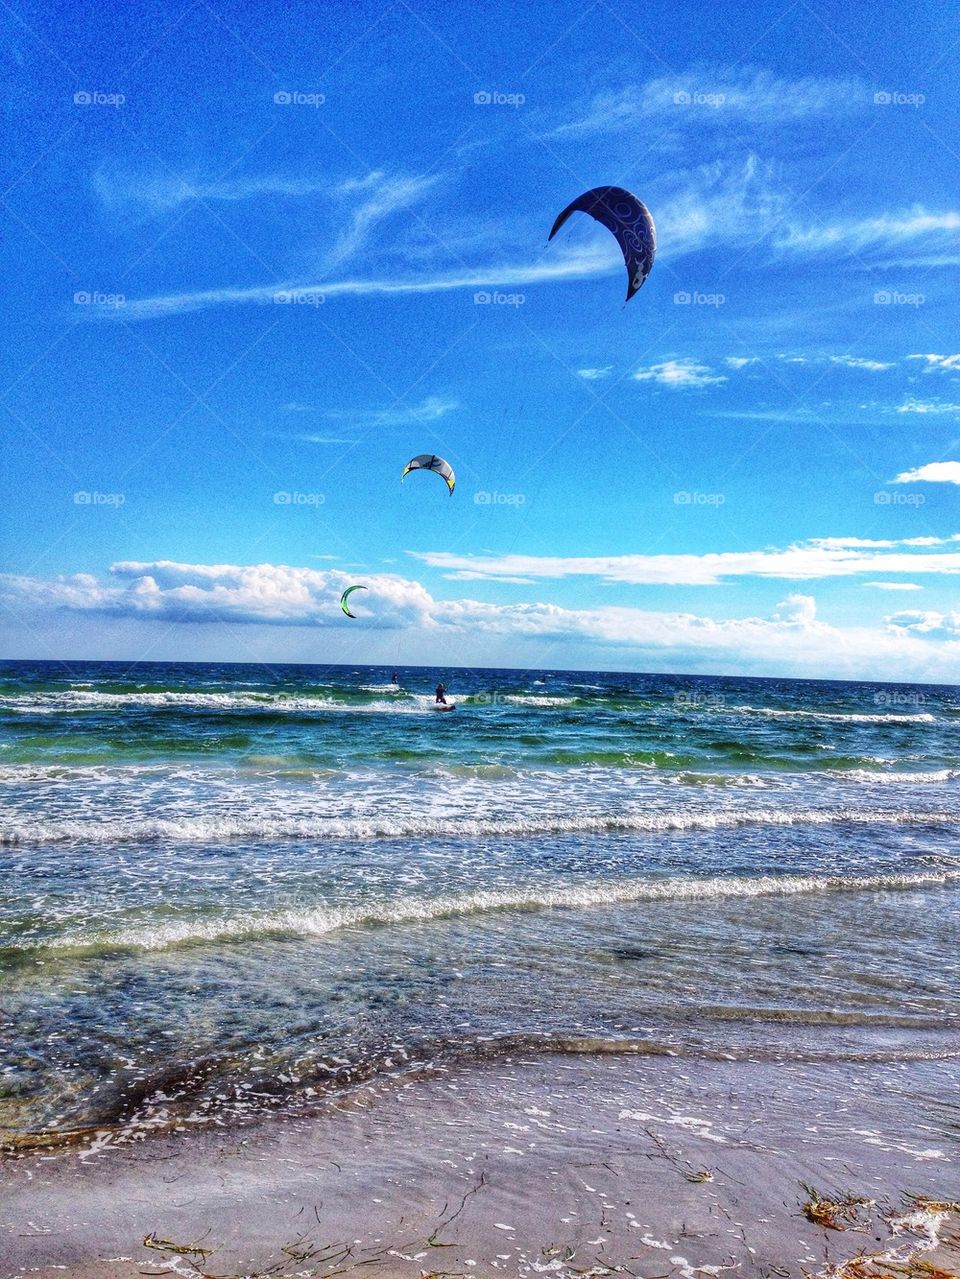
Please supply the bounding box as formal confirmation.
[0,560,960,679]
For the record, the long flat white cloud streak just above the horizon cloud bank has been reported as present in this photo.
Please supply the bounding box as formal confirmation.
[408,536,960,586]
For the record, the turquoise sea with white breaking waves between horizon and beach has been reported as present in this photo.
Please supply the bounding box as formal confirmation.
[0,663,960,1141]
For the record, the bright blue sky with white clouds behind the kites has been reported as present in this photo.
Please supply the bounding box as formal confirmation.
[0,0,960,680]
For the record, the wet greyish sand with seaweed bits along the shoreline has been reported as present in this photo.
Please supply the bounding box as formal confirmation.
[0,1055,960,1279]
